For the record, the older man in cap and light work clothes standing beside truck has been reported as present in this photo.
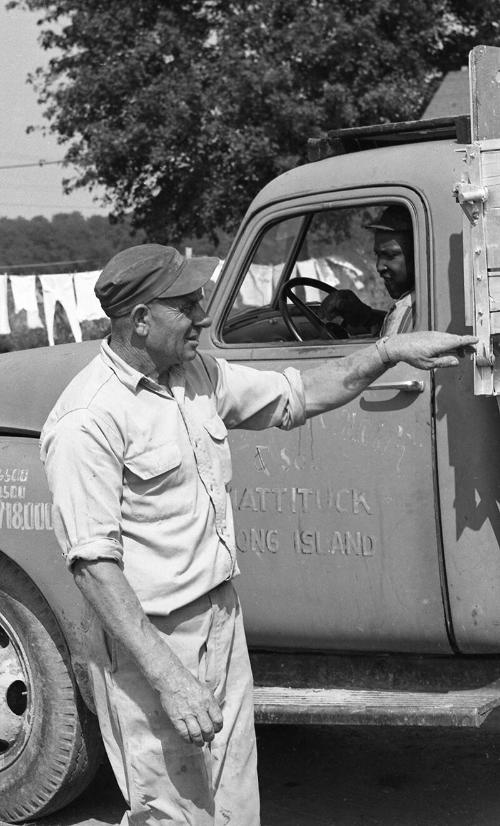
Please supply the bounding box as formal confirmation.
[41,244,476,826]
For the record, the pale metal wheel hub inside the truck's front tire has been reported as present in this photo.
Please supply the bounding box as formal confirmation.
[0,615,31,770]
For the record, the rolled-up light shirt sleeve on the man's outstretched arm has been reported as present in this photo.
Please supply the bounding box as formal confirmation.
[210,359,306,430]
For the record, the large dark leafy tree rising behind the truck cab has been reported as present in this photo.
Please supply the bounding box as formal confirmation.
[11,0,500,243]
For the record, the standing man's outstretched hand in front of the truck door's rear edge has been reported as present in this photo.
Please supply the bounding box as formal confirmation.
[385,331,479,370]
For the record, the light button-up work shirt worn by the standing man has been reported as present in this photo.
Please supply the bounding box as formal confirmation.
[41,341,305,615]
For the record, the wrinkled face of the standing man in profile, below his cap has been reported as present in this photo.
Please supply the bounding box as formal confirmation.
[148,290,211,369]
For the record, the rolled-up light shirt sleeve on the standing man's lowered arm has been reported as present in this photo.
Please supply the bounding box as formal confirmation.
[41,409,123,567]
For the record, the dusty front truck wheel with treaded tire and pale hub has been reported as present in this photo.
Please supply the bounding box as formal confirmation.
[0,554,103,823]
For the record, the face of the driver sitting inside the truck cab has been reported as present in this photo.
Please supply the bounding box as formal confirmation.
[374,230,415,299]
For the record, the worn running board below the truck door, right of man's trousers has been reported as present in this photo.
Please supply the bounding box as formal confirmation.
[254,682,500,728]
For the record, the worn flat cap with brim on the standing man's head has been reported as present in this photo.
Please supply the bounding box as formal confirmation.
[94,244,219,318]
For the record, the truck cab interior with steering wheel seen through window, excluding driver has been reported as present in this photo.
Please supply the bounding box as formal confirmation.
[222,203,413,344]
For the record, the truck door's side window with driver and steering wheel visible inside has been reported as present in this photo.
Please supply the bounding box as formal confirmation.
[222,203,414,343]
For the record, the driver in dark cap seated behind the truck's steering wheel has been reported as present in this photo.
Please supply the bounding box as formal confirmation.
[321,204,415,336]
